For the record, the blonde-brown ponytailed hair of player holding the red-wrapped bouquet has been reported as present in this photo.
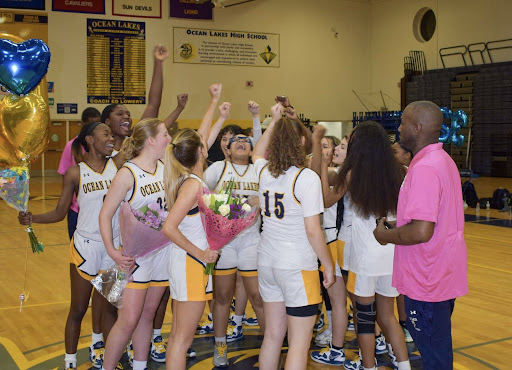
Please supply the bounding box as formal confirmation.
[164,129,203,211]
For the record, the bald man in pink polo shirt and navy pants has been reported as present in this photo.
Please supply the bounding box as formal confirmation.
[374,101,468,369]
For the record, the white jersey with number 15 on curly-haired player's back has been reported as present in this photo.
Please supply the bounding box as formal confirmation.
[255,159,324,270]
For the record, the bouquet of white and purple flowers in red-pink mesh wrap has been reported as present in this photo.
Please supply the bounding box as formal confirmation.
[198,180,259,275]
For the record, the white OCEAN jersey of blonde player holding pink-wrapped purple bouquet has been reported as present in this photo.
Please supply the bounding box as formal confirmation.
[123,161,166,209]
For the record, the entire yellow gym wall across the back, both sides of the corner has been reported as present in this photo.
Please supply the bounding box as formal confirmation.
[4,0,512,127]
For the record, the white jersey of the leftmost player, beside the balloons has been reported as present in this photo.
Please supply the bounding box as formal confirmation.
[76,158,119,241]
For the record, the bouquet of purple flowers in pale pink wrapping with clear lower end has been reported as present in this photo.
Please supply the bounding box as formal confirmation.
[91,202,170,307]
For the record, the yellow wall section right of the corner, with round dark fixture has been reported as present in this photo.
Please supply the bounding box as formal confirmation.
[371,0,512,109]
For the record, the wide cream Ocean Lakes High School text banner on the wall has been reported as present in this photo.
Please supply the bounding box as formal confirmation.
[174,27,280,68]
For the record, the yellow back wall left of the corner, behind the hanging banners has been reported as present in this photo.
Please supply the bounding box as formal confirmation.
[43,0,370,124]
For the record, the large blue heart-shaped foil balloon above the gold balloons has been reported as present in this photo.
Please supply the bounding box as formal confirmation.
[0,39,51,95]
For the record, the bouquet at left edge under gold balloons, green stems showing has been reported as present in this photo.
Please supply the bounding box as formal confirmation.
[0,166,44,253]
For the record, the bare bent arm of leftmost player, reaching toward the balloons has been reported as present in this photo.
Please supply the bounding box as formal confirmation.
[18,165,80,225]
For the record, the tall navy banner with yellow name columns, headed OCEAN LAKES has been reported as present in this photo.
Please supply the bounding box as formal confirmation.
[87,18,146,104]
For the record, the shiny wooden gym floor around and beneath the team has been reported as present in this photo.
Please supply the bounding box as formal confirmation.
[0,177,512,370]
